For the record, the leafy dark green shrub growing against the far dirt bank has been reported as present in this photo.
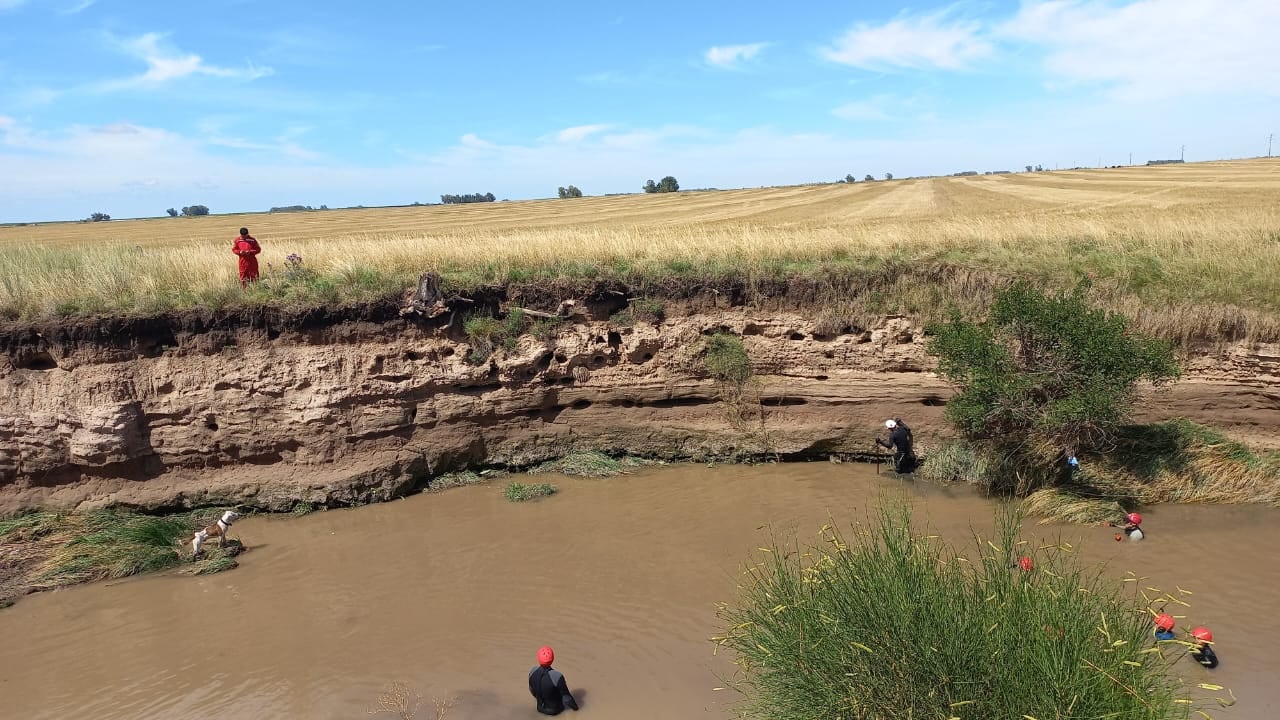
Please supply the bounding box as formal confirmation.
[927,281,1179,489]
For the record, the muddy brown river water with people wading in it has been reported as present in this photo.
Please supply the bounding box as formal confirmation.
[0,462,1280,720]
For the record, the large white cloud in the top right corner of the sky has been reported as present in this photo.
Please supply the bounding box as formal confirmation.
[996,0,1280,100]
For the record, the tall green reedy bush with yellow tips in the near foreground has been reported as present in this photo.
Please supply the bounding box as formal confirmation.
[716,509,1190,720]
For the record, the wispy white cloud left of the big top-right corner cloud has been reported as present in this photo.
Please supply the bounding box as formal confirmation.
[823,12,993,70]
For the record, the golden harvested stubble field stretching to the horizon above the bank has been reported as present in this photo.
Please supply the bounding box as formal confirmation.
[0,159,1280,324]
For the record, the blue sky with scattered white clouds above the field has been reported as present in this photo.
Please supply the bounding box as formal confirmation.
[0,0,1280,222]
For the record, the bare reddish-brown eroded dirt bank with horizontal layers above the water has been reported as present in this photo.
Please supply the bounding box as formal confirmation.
[0,299,1280,511]
